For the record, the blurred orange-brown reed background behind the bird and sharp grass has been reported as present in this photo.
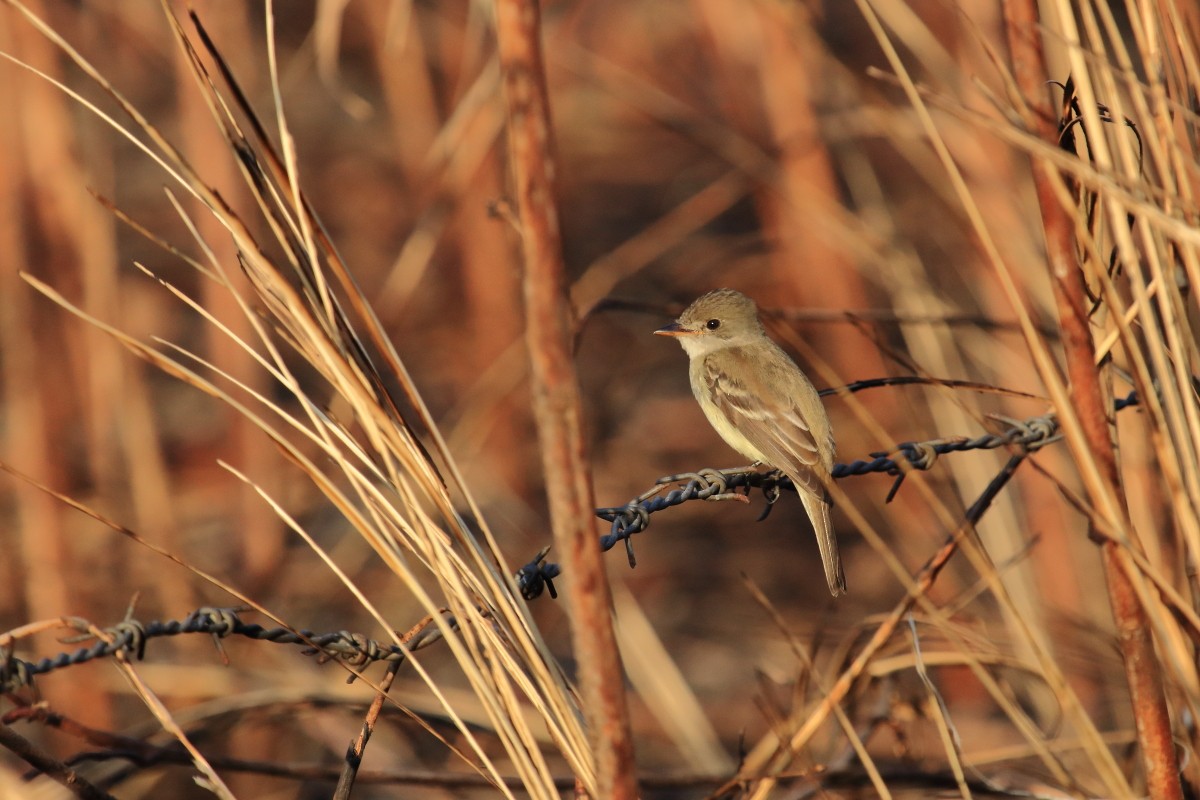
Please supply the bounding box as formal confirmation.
[0,0,1200,796]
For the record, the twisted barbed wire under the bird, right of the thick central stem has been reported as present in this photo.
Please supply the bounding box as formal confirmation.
[595,391,1138,567]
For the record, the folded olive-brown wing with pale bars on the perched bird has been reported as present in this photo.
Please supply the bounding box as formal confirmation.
[703,354,828,498]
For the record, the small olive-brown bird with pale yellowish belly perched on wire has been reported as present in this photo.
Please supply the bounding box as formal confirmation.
[654,289,846,597]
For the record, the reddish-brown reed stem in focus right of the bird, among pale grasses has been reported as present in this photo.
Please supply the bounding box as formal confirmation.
[1004,0,1183,799]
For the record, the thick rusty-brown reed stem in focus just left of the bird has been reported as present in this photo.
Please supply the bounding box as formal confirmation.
[496,0,637,800]
